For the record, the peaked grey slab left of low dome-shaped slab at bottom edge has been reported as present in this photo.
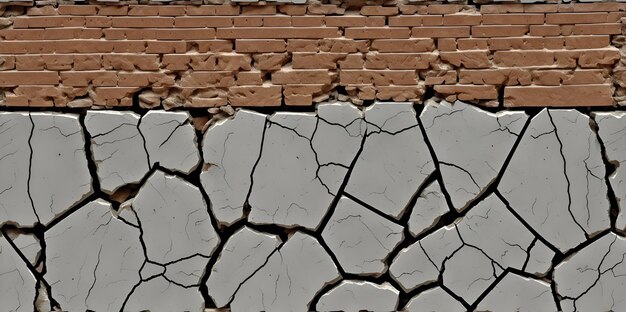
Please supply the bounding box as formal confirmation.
[230,232,341,311]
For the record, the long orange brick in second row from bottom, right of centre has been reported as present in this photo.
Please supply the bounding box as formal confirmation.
[339,69,418,86]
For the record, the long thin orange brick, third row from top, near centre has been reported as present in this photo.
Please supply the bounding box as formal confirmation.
[216,27,340,39]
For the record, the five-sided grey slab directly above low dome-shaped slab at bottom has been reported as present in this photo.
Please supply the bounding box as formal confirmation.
[322,197,404,276]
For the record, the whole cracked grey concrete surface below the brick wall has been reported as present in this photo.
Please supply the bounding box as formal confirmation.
[0,100,626,311]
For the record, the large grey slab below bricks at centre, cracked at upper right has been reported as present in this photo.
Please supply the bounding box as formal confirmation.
[249,104,362,229]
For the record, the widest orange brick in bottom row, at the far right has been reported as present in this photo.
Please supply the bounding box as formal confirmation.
[504,84,614,107]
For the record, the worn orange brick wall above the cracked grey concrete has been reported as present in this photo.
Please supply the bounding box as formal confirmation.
[0,3,626,108]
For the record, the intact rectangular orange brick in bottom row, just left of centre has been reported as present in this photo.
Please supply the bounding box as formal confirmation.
[228,86,282,106]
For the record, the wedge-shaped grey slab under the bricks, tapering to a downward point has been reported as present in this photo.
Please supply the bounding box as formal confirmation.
[420,101,528,211]
